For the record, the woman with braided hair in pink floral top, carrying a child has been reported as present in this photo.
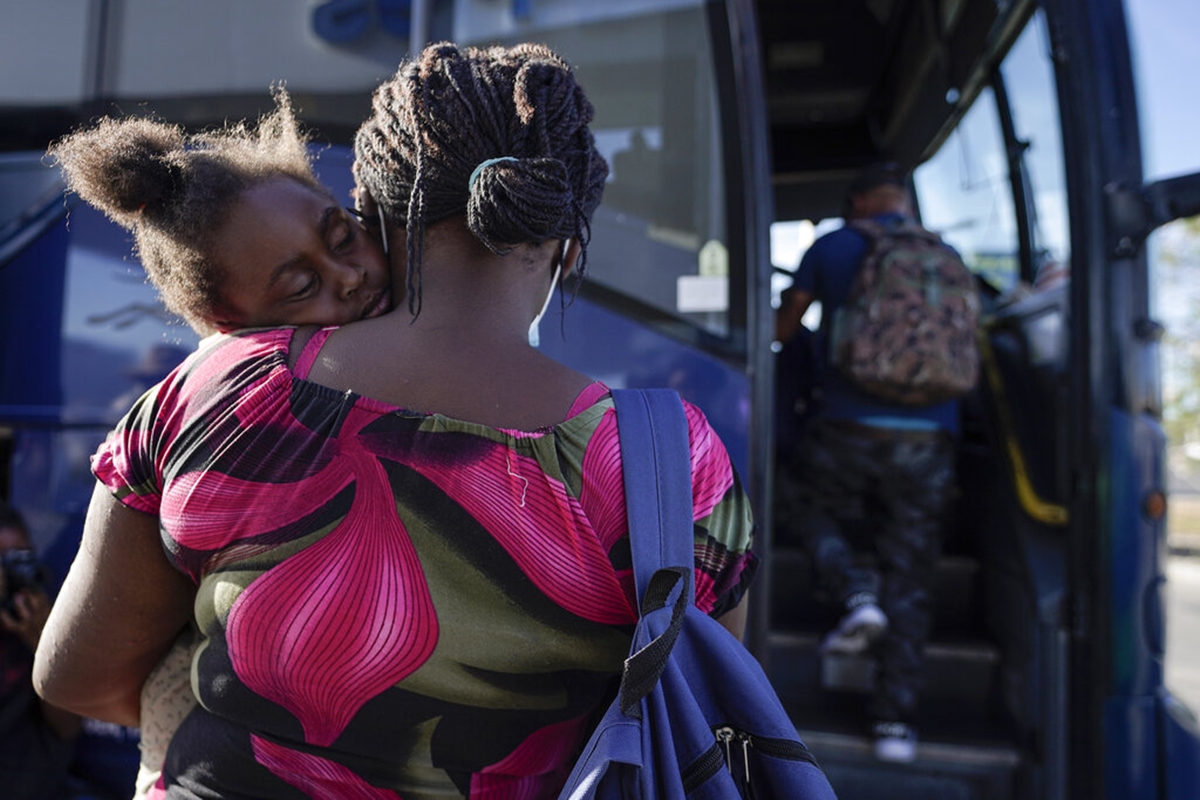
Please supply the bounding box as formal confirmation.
[37,43,754,800]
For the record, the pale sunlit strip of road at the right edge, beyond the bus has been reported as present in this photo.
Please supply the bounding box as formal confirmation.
[1166,555,1200,714]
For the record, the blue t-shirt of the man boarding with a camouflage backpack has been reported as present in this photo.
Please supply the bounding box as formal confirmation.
[794,213,959,434]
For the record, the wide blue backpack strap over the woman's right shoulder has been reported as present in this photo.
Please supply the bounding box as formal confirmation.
[612,389,696,613]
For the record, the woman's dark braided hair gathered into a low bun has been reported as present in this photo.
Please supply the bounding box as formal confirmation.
[354,42,608,314]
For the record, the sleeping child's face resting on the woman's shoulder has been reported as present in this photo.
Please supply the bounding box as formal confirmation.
[214,178,391,330]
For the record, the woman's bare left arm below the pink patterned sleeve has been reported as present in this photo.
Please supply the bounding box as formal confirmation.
[34,483,196,727]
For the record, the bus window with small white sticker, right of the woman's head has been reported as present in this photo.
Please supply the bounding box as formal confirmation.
[460,4,729,338]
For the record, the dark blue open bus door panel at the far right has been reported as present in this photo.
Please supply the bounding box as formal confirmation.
[1045,0,1200,798]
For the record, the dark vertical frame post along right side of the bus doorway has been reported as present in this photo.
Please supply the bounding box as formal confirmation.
[1042,0,1151,798]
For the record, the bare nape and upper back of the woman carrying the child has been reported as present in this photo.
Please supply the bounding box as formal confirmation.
[300,223,590,431]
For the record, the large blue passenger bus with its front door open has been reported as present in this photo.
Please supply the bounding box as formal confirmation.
[0,0,1200,800]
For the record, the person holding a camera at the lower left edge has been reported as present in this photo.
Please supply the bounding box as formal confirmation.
[0,501,80,800]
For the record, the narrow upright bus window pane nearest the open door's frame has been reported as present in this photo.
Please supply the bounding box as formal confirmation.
[1000,12,1070,285]
